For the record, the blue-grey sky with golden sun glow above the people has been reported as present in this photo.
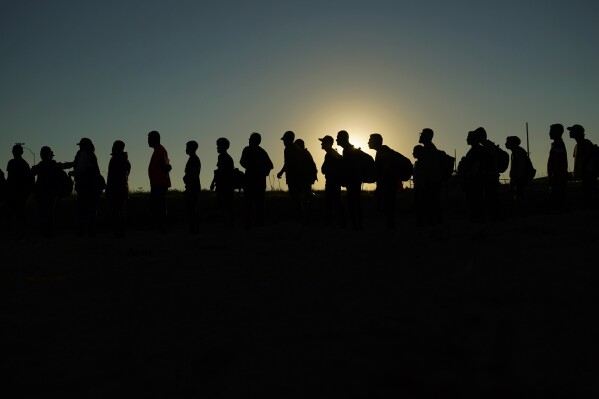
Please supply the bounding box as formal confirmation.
[0,0,599,191]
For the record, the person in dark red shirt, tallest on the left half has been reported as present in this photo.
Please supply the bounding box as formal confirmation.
[148,130,172,233]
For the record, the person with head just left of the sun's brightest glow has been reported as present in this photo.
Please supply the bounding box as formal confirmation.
[336,130,364,230]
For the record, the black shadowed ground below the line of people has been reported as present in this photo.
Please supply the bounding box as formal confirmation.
[0,183,599,398]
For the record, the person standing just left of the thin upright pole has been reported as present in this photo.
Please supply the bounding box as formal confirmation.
[505,136,532,216]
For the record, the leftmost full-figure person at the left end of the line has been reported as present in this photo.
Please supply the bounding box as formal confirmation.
[6,144,35,238]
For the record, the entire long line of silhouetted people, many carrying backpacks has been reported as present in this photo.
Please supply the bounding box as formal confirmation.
[0,124,599,238]
